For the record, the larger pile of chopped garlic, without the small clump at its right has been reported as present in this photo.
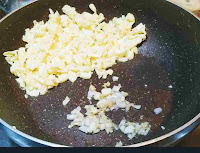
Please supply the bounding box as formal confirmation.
[67,84,145,134]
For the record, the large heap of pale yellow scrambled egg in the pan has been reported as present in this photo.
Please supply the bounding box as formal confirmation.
[4,4,146,96]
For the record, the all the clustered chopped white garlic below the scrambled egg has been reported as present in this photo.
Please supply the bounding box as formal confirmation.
[67,84,151,140]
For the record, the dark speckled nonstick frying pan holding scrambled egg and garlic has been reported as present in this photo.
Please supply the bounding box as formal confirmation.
[0,0,200,147]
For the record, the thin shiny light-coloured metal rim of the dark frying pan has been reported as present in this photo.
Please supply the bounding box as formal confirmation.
[0,0,200,147]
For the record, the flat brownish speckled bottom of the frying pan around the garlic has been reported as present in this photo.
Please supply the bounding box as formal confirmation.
[12,55,173,146]
